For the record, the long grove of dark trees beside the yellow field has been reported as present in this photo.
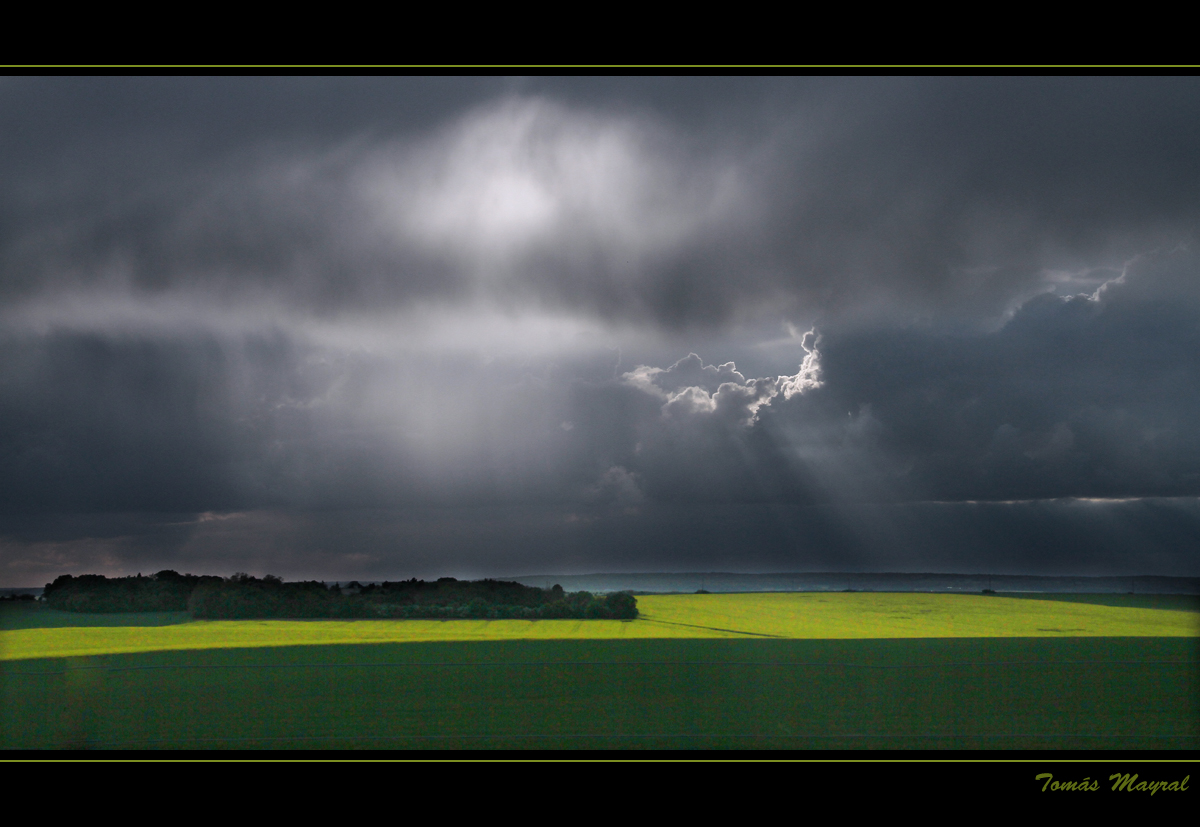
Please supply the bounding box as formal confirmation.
[42,570,637,619]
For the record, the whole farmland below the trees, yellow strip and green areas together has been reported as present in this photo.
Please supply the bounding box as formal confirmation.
[0,593,1200,749]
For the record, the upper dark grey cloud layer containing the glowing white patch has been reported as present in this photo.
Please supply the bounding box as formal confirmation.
[0,78,1200,328]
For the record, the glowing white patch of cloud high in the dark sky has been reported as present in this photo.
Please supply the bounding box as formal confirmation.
[364,98,736,271]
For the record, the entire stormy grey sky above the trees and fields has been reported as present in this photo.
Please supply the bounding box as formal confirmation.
[0,77,1200,586]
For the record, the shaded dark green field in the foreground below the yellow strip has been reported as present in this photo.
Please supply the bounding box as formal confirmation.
[0,595,1200,750]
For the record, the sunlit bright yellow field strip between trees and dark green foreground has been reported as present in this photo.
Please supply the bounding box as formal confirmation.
[0,593,1200,660]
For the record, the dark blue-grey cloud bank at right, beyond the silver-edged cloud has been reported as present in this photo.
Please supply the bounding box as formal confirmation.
[796,244,1200,499]
